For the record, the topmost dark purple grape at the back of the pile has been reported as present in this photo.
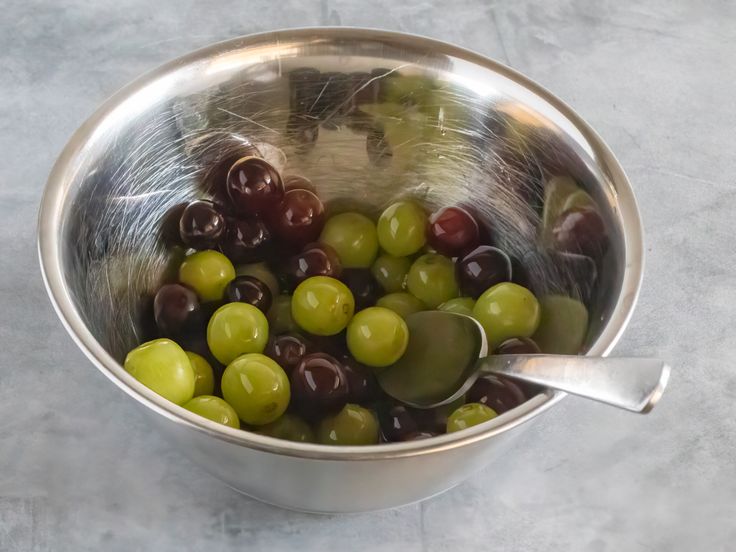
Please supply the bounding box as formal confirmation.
[226,157,284,215]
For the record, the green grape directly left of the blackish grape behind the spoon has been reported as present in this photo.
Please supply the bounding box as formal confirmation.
[406,253,459,309]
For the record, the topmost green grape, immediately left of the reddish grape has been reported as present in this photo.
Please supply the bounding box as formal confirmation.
[377,201,427,257]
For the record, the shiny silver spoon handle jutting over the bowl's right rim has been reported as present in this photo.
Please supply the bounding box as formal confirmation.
[477,355,670,414]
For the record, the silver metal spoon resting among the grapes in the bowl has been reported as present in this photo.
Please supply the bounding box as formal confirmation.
[378,311,670,414]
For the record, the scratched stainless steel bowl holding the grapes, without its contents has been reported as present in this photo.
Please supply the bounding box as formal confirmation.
[39,28,643,512]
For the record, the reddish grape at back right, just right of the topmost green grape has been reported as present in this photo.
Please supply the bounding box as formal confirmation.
[427,207,480,257]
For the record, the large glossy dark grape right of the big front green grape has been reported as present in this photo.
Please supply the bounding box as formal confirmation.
[290,353,350,419]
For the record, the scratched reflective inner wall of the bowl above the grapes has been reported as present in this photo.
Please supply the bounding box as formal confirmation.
[42,29,640,406]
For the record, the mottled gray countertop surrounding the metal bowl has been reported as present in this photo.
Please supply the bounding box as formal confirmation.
[0,0,736,552]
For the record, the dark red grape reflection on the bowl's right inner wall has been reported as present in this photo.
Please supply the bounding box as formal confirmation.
[552,207,607,258]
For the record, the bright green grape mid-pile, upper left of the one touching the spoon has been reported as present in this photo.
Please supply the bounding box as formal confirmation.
[291,276,355,335]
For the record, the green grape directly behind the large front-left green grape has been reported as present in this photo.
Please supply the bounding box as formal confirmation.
[207,303,268,364]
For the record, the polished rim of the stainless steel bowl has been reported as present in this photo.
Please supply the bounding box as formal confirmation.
[38,27,644,461]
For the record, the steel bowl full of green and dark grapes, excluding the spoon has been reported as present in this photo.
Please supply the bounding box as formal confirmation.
[39,29,642,512]
